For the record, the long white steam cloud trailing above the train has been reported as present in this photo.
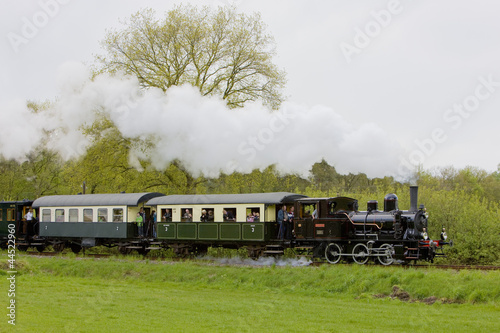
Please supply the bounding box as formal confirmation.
[0,63,402,177]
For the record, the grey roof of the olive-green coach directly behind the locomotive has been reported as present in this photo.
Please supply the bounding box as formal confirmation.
[147,192,306,206]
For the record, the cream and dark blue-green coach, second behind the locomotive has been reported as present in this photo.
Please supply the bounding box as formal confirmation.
[33,192,164,252]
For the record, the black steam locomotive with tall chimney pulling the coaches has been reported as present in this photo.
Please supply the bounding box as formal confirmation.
[295,186,450,265]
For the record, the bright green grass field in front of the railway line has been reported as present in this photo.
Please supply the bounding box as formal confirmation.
[0,253,500,332]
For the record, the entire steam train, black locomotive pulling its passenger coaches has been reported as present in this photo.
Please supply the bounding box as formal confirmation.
[0,186,450,265]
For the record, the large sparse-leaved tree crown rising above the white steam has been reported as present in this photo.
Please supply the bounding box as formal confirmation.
[97,6,285,108]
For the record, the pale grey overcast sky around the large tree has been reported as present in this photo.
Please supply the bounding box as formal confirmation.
[0,0,500,176]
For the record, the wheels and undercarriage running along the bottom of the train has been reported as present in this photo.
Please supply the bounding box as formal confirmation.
[17,238,445,266]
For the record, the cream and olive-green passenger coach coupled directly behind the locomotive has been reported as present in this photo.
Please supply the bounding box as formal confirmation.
[143,192,305,255]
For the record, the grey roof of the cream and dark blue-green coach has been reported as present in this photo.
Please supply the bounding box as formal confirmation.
[32,192,164,208]
